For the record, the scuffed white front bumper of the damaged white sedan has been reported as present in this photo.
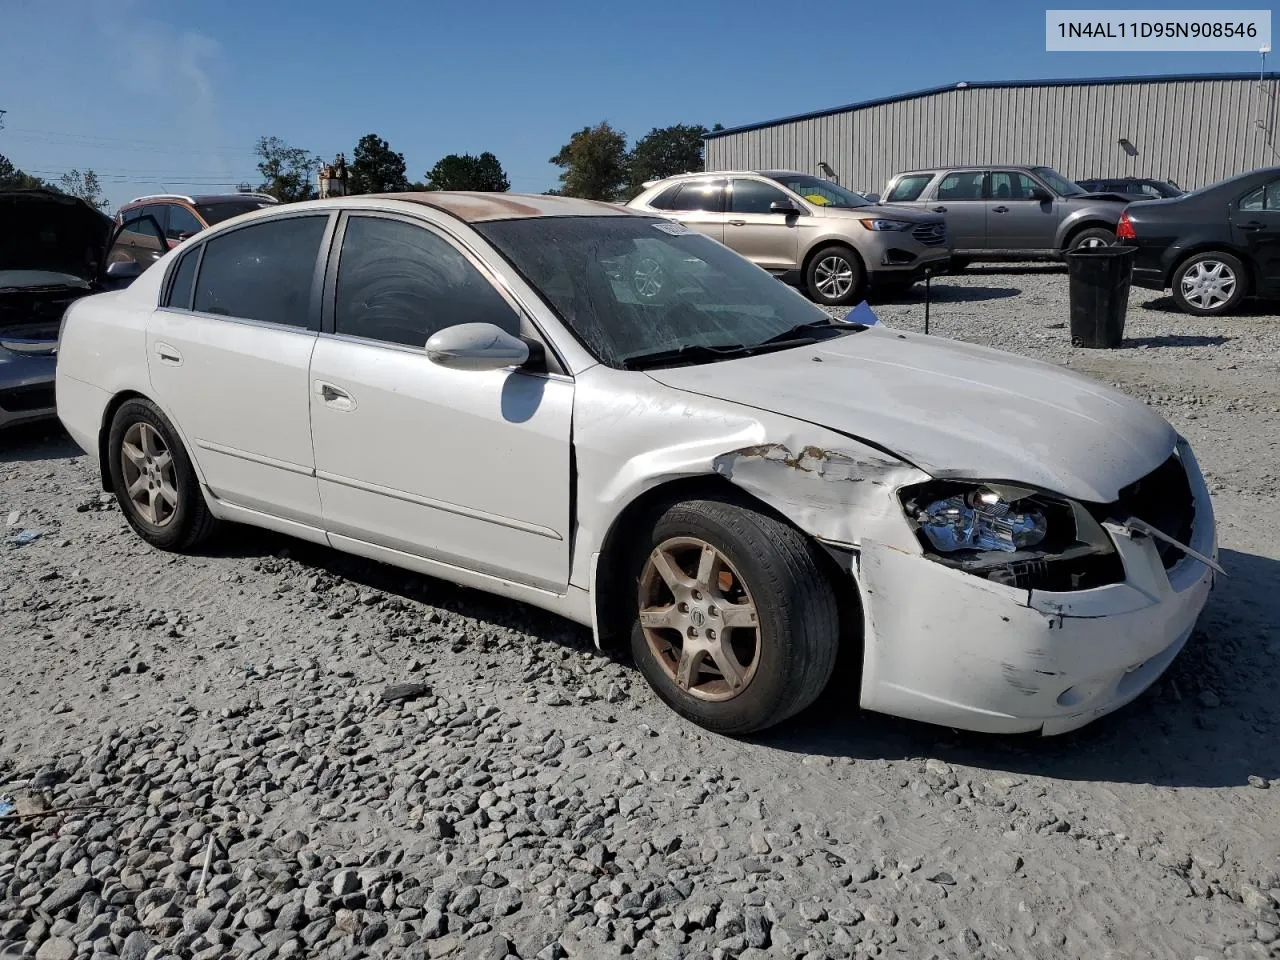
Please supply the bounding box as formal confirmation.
[859,444,1217,735]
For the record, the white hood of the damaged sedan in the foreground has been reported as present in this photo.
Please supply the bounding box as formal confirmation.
[648,326,1176,503]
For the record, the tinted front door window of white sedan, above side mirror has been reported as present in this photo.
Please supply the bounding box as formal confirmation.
[334,216,520,347]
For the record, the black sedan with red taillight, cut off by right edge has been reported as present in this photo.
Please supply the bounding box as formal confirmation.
[1116,166,1280,316]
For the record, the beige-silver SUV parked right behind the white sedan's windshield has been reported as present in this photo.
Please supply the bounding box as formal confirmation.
[627,170,951,306]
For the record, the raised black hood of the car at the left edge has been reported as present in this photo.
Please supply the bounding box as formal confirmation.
[0,189,111,284]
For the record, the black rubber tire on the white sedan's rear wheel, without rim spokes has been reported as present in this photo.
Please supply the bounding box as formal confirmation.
[106,399,216,550]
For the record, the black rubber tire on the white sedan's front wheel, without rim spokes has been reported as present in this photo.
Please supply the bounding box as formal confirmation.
[625,500,840,735]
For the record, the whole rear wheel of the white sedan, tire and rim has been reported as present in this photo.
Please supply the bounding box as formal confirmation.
[106,399,215,550]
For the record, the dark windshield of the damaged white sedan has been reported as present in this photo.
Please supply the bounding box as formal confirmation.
[475,216,854,367]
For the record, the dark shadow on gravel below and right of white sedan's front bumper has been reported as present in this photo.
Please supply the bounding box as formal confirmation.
[756,550,1280,787]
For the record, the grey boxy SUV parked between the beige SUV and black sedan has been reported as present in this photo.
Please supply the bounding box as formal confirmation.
[884,164,1129,269]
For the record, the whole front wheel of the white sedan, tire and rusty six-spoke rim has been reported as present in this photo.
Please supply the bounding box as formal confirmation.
[631,500,840,735]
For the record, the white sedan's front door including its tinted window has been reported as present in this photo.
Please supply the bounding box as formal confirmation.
[310,215,573,593]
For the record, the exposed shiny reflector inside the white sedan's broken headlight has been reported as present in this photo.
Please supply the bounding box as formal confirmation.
[915,486,1047,553]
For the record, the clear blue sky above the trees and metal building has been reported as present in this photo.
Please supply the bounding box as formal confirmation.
[0,0,1272,206]
